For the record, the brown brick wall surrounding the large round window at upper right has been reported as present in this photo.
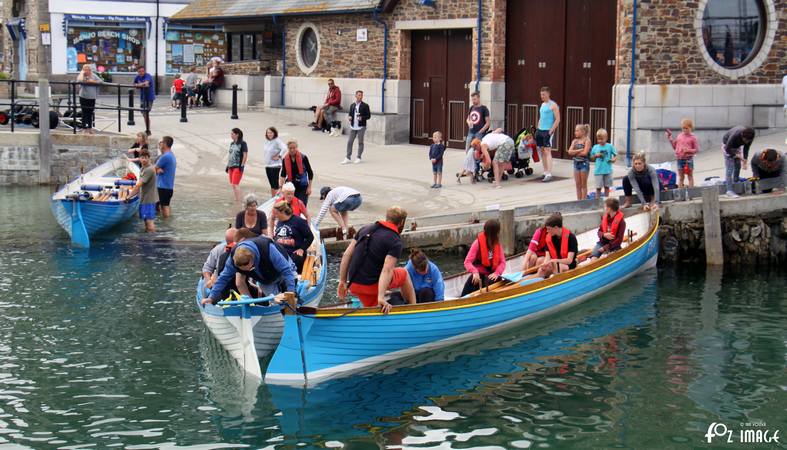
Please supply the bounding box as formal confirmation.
[616,0,787,84]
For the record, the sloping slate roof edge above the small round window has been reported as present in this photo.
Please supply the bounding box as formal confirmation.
[170,0,380,21]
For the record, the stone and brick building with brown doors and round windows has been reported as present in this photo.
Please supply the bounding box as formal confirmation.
[172,0,787,161]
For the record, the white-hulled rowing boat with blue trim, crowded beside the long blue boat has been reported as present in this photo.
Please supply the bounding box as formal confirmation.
[196,199,328,379]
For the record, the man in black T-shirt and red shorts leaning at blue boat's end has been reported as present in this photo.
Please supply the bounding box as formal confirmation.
[337,206,415,314]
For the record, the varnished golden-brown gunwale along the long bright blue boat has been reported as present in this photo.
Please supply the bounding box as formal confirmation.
[301,212,661,319]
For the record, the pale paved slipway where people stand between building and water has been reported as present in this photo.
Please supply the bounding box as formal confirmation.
[118,105,787,237]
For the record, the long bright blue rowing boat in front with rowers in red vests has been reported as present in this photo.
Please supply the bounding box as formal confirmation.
[265,213,659,385]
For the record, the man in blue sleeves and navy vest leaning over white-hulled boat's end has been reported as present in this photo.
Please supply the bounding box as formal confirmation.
[202,236,297,305]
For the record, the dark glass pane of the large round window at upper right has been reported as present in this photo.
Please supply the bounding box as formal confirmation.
[702,0,766,69]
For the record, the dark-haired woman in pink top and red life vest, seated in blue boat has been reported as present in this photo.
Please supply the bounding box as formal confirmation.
[461,219,506,297]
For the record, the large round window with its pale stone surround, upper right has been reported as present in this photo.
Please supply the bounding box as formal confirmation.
[695,0,776,78]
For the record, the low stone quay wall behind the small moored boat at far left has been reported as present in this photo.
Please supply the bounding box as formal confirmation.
[0,132,133,186]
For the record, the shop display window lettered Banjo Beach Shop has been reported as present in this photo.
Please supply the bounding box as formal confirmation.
[66,22,145,73]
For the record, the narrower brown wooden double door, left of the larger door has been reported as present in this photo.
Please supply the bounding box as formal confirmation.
[410,30,472,148]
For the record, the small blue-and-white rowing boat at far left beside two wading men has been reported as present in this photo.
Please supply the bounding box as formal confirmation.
[52,158,139,247]
